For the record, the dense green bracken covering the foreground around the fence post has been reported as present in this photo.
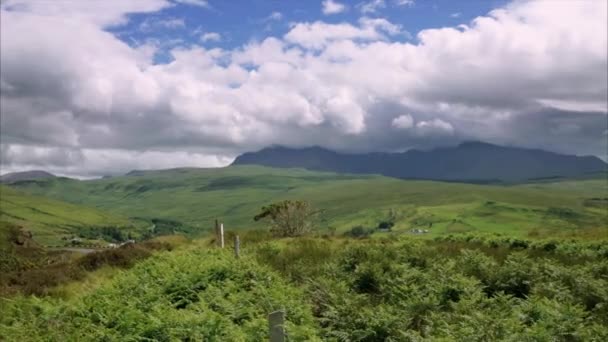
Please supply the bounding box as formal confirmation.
[0,232,608,341]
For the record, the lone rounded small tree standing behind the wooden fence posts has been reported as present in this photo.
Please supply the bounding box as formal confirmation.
[253,200,319,237]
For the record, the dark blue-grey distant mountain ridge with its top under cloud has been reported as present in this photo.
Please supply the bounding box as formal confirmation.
[233,141,608,182]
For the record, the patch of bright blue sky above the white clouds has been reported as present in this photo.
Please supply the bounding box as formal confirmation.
[108,0,508,63]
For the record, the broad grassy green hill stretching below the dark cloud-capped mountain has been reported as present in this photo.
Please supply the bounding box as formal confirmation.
[5,166,608,236]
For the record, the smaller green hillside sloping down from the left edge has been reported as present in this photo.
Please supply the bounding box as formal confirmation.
[0,186,139,246]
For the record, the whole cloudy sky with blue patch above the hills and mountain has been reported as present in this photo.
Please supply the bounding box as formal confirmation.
[0,0,608,177]
